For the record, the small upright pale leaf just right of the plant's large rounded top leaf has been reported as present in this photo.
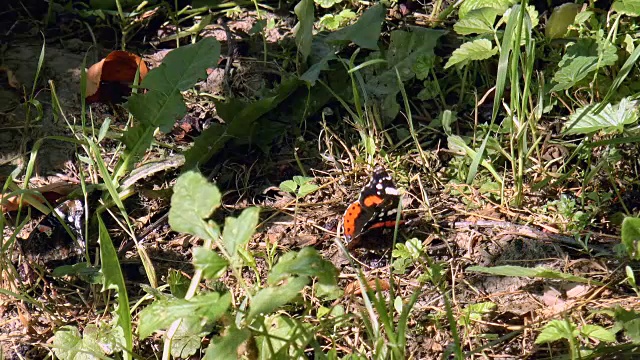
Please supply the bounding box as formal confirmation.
[222,207,260,260]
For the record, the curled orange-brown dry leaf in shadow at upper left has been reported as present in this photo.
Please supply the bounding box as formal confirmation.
[86,51,149,103]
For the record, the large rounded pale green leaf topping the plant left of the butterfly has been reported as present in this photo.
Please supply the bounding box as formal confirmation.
[169,171,220,239]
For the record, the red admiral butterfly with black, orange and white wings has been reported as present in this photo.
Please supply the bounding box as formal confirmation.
[343,167,400,242]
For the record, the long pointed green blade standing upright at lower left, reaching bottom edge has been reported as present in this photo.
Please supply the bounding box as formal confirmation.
[97,215,133,360]
